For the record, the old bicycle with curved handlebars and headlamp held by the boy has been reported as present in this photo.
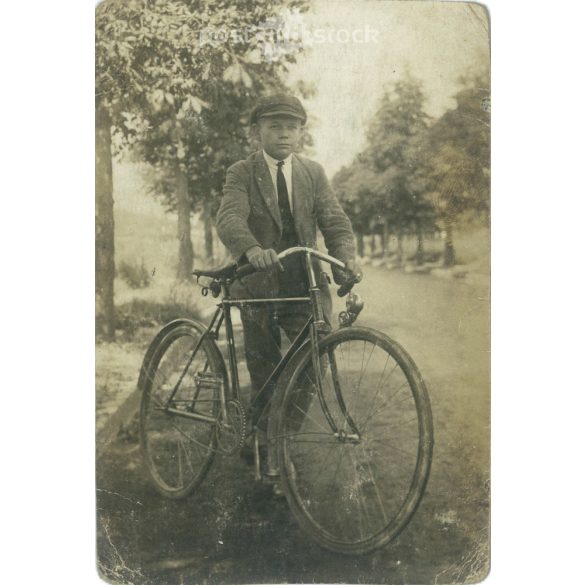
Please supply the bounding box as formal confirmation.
[139,247,433,554]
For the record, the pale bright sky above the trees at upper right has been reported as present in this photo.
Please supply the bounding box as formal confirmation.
[289,0,489,177]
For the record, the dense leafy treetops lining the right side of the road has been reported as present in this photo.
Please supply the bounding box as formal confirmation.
[333,68,490,265]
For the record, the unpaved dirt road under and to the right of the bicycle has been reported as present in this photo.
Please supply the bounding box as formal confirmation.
[97,267,490,584]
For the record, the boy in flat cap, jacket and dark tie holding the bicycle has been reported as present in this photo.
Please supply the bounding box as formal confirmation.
[217,94,361,452]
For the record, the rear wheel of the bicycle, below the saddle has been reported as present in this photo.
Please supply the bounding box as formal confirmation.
[140,321,227,499]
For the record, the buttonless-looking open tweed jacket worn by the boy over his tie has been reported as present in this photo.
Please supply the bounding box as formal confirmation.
[216,151,355,296]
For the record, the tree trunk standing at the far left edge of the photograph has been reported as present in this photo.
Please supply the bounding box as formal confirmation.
[95,104,116,341]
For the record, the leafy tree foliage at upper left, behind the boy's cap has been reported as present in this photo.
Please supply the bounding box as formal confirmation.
[96,0,307,282]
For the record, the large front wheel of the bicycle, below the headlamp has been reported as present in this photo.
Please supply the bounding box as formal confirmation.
[277,327,433,554]
